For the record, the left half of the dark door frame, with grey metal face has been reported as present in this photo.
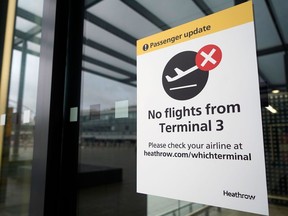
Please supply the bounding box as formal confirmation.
[29,0,68,216]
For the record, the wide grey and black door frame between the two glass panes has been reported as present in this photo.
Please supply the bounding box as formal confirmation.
[29,0,84,216]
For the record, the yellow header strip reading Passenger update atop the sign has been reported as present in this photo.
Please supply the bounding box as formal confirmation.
[137,1,253,55]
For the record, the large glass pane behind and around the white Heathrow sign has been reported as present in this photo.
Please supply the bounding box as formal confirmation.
[78,0,288,216]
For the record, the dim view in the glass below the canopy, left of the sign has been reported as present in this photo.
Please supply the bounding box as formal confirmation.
[79,72,146,215]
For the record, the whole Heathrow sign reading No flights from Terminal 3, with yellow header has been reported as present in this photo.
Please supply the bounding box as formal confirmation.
[137,1,268,215]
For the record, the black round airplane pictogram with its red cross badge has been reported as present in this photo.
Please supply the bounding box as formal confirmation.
[162,44,222,100]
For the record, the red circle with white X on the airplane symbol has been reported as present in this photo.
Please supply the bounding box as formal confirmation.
[195,44,222,71]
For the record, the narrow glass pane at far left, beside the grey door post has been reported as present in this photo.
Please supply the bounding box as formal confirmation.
[0,0,43,216]
